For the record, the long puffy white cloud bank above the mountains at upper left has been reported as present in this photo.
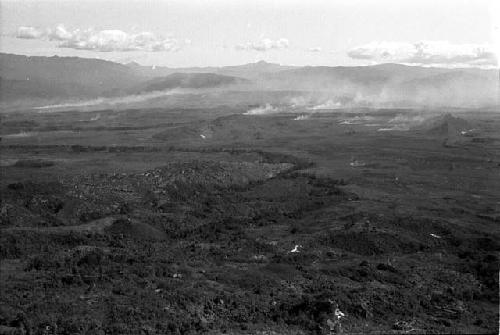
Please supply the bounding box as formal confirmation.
[16,24,184,52]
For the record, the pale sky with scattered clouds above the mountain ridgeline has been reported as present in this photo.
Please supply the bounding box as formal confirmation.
[0,0,500,68]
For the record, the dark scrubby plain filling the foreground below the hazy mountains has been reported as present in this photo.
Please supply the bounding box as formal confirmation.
[0,106,500,334]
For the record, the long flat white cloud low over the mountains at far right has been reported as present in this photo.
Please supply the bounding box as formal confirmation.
[347,41,498,67]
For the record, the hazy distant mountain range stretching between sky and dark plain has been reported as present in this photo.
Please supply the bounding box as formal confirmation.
[0,54,499,105]
